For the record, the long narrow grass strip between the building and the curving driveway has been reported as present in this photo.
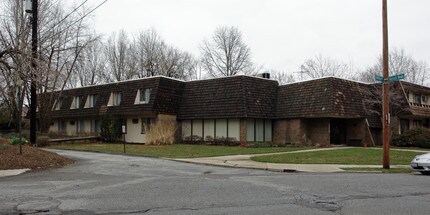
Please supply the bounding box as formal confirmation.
[49,143,304,158]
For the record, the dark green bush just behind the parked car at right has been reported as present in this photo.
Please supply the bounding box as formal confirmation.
[393,128,430,148]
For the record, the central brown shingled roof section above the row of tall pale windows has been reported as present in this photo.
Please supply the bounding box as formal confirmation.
[178,76,278,119]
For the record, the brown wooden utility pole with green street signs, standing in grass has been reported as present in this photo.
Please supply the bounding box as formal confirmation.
[382,0,390,169]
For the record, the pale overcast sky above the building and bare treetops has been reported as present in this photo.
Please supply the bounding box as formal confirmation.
[87,0,430,73]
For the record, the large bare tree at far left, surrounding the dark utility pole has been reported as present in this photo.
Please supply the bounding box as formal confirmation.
[0,0,97,132]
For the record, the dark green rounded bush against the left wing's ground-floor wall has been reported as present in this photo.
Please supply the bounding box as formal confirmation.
[100,115,121,142]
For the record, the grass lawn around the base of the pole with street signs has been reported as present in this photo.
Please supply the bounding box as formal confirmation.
[251,148,423,165]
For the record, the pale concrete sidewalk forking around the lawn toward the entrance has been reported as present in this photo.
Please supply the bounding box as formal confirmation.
[172,147,409,173]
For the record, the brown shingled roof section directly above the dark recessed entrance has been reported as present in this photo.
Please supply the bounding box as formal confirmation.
[277,77,365,118]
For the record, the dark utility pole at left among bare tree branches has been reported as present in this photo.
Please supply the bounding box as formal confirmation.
[26,0,38,145]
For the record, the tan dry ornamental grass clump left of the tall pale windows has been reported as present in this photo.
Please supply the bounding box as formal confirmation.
[145,115,176,146]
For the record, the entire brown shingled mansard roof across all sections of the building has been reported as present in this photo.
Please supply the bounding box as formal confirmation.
[42,76,430,127]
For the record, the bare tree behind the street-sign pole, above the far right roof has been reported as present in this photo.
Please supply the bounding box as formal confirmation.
[360,48,430,85]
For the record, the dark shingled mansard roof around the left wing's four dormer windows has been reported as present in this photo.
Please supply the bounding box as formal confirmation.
[46,76,183,118]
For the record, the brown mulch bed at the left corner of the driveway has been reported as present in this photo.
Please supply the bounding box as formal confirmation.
[0,144,73,170]
